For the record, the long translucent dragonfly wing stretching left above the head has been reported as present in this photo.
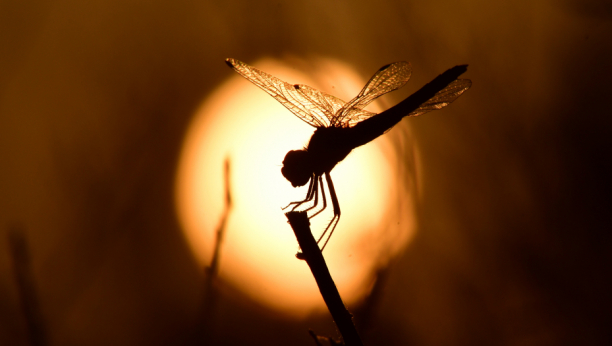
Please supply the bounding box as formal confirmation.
[225,59,334,127]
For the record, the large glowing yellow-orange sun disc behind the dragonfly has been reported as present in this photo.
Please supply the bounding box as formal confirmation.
[177,56,414,316]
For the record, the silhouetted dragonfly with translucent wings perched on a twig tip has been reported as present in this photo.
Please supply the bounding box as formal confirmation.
[225,59,472,249]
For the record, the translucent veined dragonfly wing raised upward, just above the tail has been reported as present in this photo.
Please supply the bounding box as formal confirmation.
[331,61,412,126]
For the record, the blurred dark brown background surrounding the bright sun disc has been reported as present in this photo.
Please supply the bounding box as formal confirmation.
[0,0,612,345]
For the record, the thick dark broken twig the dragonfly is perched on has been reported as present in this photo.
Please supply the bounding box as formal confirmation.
[285,211,363,346]
